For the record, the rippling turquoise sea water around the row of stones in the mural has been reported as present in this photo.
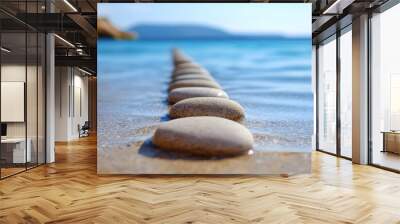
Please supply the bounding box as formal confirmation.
[98,39,313,151]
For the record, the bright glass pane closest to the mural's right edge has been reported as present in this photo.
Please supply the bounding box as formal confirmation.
[318,38,336,153]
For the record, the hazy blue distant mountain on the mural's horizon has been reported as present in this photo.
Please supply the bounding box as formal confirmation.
[128,24,288,40]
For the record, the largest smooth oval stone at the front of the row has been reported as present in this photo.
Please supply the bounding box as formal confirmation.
[152,117,254,157]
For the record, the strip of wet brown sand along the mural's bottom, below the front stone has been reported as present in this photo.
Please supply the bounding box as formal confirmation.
[97,141,311,175]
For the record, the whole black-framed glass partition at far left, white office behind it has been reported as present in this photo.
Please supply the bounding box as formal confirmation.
[0,1,46,179]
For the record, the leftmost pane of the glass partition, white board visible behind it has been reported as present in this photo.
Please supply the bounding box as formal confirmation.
[1,29,27,177]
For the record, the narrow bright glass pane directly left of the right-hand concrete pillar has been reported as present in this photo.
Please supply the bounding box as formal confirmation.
[340,30,352,158]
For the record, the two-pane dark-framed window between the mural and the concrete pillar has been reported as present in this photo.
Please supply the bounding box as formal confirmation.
[316,25,352,159]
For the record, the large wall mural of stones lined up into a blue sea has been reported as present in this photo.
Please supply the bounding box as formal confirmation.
[97,3,313,174]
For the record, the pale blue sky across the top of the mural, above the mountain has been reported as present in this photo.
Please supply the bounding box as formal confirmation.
[98,3,311,36]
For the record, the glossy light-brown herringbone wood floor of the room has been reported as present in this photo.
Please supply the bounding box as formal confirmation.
[0,137,400,224]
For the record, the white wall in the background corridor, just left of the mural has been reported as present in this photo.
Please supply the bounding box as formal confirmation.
[55,67,88,141]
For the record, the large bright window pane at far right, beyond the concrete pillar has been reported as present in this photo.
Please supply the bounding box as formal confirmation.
[371,5,400,170]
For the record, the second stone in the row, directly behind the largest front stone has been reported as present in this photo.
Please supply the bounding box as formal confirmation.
[169,97,244,121]
